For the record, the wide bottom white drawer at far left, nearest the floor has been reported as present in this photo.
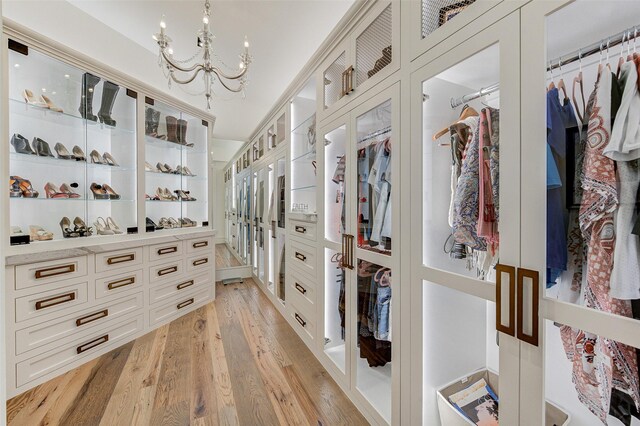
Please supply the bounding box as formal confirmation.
[16,315,144,387]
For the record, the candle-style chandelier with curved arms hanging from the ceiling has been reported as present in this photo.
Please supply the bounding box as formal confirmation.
[153,0,252,110]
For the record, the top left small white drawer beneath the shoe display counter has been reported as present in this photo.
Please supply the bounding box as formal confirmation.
[16,256,87,290]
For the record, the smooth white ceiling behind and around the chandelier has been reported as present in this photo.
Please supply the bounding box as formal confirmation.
[68,0,353,140]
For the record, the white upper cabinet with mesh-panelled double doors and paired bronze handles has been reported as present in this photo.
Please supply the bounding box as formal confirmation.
[316,1,400,121]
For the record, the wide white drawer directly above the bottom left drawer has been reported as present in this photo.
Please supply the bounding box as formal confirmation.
[16,292,144,355]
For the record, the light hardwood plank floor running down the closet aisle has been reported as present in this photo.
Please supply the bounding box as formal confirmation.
[7,279,367,426]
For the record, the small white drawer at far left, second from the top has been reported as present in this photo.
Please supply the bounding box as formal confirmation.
[15,281,89,322]
